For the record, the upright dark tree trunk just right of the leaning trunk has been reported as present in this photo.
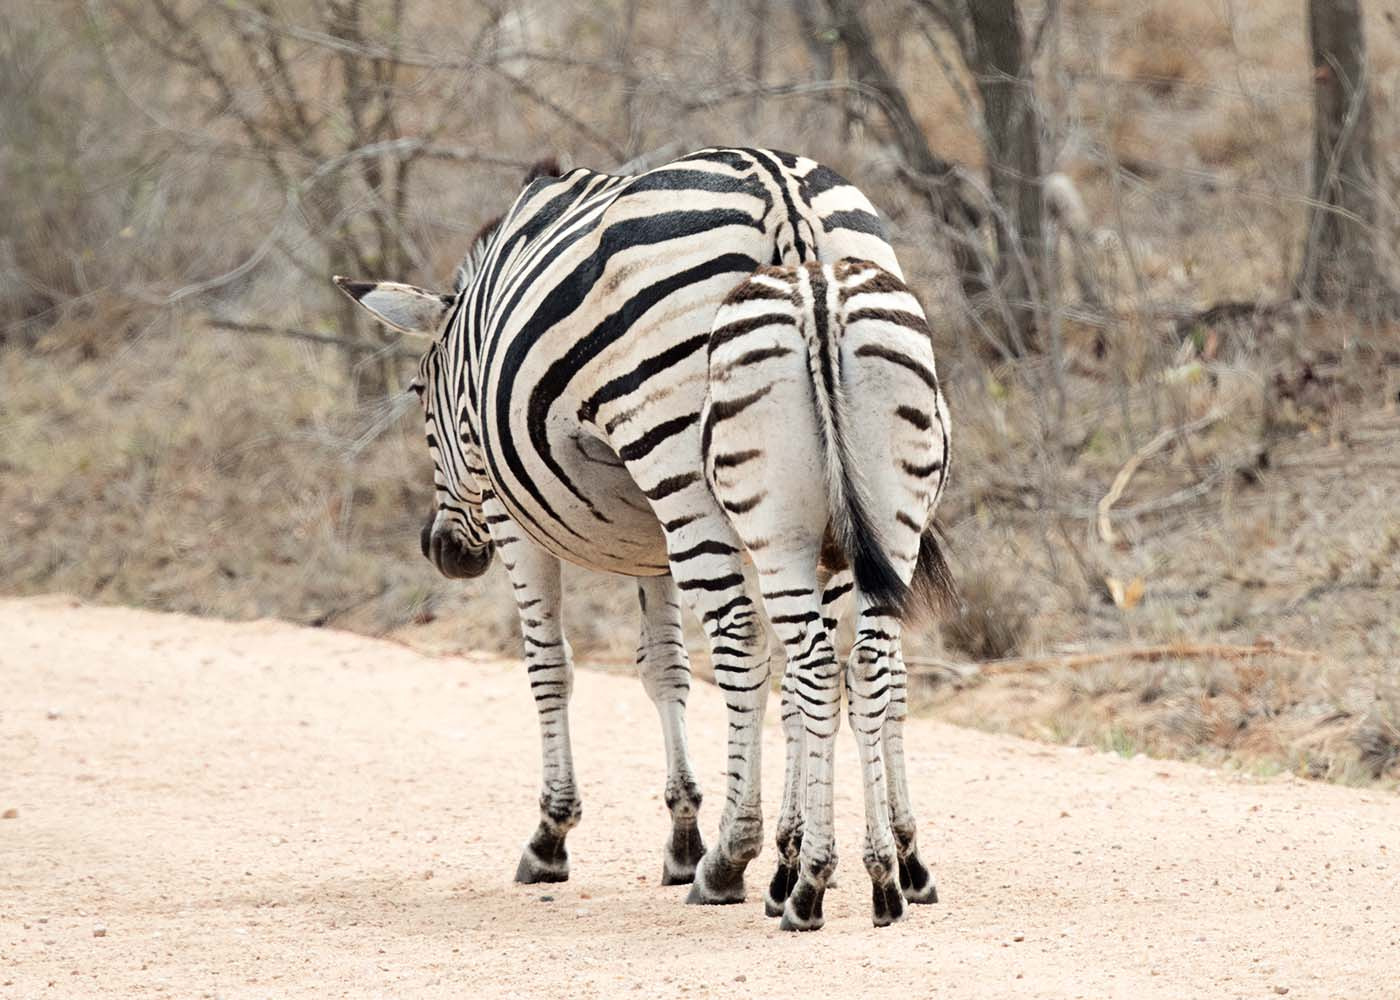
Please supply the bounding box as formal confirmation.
[966,0,1047,350]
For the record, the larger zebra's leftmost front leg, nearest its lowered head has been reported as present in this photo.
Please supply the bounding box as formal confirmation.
[498,529,582,884]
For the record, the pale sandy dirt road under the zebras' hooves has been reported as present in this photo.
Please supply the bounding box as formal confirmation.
[0,598,1400,999]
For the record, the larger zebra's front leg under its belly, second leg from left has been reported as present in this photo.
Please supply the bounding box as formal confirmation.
[637,576,704,885]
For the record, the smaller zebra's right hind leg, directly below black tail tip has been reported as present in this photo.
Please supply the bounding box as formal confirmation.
[846,595,904,927]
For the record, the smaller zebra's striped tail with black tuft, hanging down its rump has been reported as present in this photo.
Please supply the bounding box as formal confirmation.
[808,268,912,619]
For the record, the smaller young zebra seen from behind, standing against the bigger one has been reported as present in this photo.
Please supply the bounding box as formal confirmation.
[701,259,953,930]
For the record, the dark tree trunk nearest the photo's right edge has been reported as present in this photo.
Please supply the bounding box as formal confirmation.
[1295,0,1394,318]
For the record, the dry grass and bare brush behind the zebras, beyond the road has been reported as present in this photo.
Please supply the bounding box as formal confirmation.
[0,0,1400,784]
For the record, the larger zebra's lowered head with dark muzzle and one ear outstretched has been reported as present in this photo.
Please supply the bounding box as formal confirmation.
[335,272,493,578]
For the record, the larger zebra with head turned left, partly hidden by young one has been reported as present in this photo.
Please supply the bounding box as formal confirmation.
[337,147,946,924]
